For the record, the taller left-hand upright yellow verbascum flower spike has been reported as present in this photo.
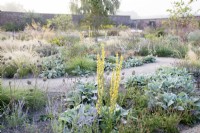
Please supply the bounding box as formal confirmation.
[96,45,105,114]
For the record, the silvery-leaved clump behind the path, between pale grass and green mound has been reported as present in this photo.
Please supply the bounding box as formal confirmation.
[40,55,65,78]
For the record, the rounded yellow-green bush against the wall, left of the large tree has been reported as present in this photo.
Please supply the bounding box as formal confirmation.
[47,14,73,31]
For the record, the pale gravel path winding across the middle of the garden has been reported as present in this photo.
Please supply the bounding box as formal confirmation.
[3,58,177,92]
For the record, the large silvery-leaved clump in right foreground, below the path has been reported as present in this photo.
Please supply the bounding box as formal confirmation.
[125,68,199,111]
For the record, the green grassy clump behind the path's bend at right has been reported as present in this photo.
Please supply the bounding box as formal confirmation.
[137,35,188,58]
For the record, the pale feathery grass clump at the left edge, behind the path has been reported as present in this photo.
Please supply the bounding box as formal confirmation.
[0,40,42,77]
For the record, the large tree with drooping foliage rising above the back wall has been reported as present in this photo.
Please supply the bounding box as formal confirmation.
[70,0,120,29]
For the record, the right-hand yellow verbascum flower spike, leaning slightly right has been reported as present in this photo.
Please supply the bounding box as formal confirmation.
[109,54,123,114]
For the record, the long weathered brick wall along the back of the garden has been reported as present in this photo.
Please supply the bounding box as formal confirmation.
[0,11,200,29]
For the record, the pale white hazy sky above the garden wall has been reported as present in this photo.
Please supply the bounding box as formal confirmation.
[0,0,200,18]
